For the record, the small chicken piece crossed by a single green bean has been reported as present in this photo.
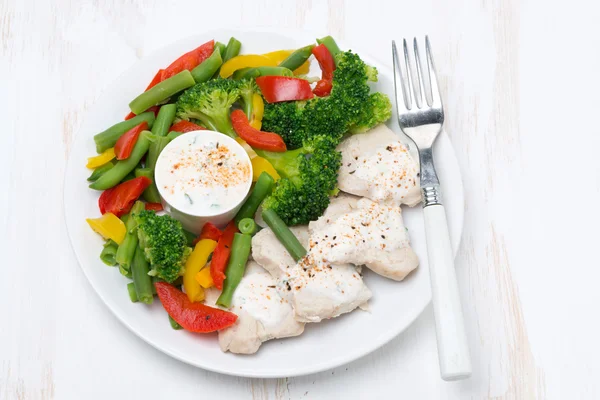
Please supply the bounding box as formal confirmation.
[252,225,308,278]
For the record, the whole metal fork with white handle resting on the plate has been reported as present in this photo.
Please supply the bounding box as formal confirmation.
[392,36,471,381]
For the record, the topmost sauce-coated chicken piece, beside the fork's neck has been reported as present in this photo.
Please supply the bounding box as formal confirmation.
[337,124,421,207]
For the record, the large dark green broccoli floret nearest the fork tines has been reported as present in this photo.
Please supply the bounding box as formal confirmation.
[263,51,391,149]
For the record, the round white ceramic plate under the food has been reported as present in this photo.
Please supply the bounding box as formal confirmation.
[64,30,464,378]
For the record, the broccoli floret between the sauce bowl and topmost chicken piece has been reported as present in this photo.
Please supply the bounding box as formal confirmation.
[256,135,341,225]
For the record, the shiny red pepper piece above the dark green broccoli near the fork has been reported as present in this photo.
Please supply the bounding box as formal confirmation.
[256,76,314,103]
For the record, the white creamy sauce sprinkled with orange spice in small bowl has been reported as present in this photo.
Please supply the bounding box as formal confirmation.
[155,131,252,216]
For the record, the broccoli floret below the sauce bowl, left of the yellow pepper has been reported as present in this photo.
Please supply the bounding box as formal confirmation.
[134,210,192,283]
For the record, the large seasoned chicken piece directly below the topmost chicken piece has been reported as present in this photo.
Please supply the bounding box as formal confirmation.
[309,199,419,281]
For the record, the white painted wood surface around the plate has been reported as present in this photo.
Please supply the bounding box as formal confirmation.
[0,0,600,400]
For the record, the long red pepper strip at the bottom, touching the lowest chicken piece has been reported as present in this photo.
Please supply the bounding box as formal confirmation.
[154,282,237,333]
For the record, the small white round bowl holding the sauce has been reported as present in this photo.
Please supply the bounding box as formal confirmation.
[154,130,252,234]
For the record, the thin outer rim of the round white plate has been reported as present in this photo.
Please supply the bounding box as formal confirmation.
[62,27,465,378]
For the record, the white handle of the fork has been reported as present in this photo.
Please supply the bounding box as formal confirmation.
[423,204,471,381]
